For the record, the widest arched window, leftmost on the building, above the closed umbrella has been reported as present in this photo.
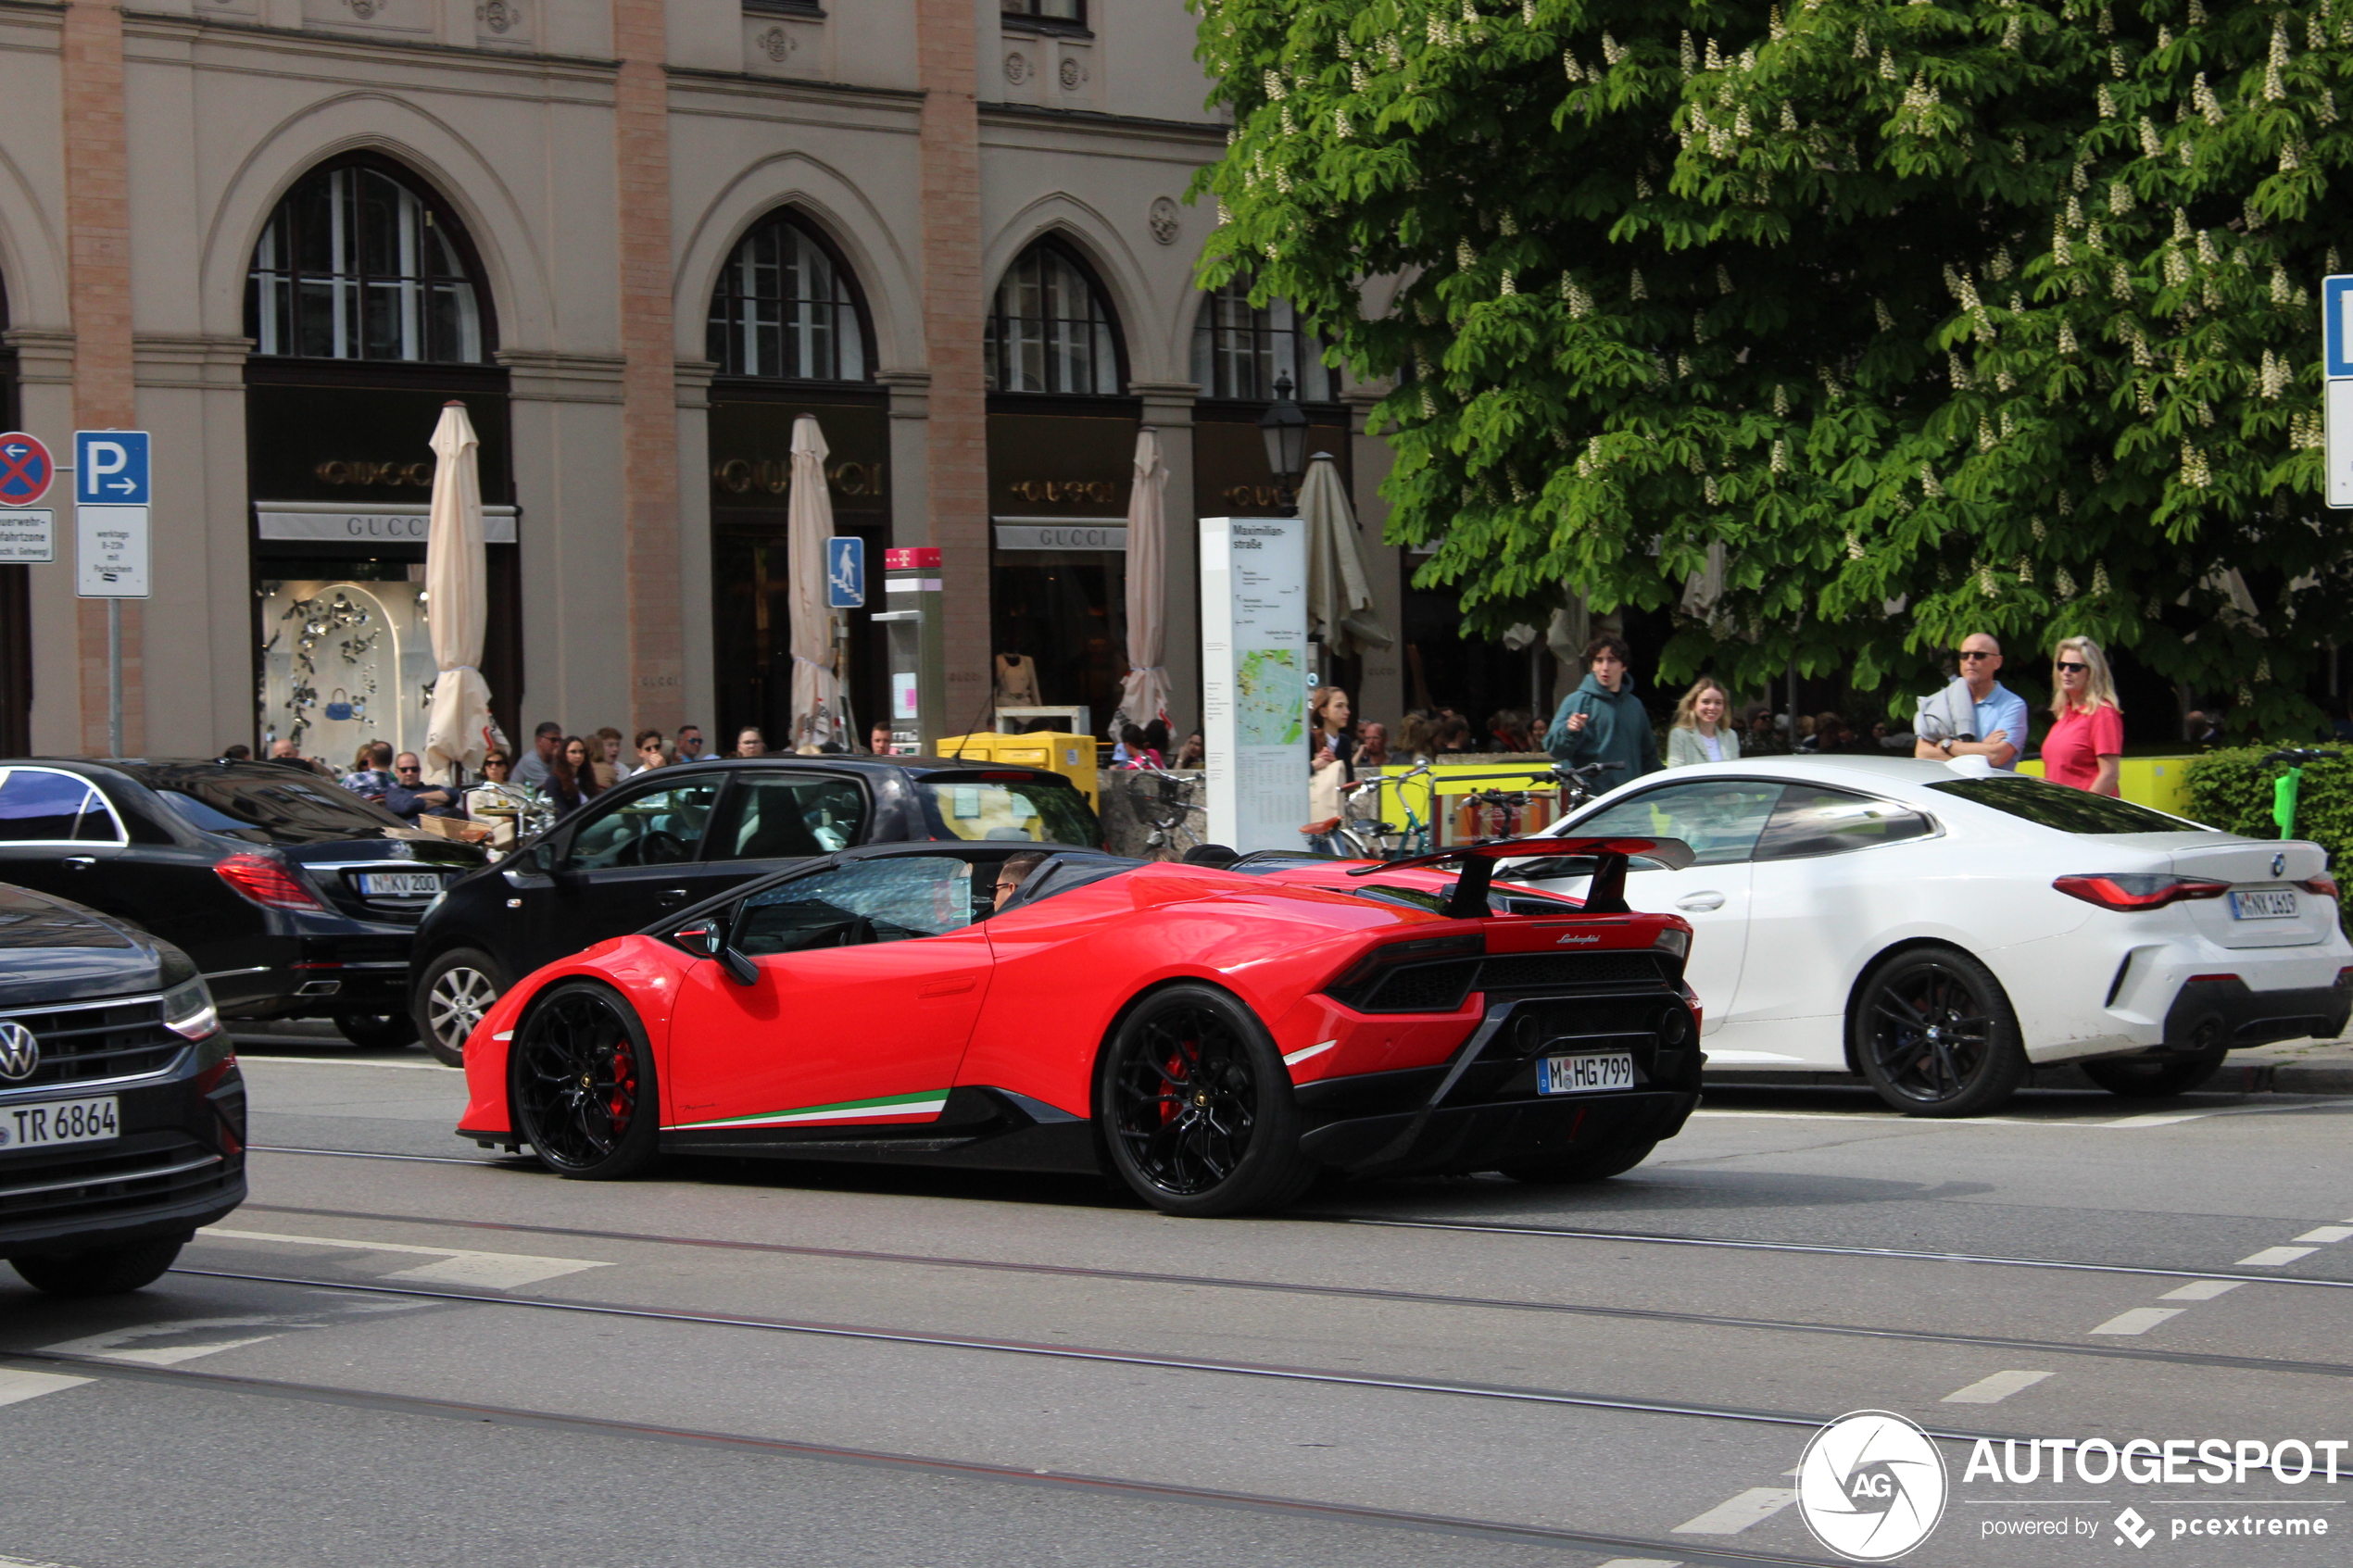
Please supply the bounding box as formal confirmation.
[245,162,489,364]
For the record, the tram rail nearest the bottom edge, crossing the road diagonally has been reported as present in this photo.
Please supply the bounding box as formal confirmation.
[0,1354,1838,1568]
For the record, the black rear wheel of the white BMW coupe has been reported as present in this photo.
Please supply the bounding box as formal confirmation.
[1847,947,2026,1117]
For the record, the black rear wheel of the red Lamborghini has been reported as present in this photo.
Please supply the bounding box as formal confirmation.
[1097,985,1317,1218]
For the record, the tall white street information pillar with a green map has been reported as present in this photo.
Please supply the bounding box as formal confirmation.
[1200,517,1308,853]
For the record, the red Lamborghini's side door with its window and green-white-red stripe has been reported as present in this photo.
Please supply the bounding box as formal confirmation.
[663,853,990,1131]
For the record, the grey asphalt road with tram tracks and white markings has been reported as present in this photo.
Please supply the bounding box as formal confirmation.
[0,1039,2353,1568]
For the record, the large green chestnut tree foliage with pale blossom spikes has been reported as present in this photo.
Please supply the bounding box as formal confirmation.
[1200,0,2353,729]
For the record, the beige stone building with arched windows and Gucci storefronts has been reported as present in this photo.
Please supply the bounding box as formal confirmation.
[0,0,1525,759]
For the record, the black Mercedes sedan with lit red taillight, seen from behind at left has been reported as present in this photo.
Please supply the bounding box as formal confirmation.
[0,757,484,1047]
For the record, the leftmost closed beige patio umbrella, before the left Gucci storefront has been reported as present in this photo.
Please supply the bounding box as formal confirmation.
[423,399,506,785]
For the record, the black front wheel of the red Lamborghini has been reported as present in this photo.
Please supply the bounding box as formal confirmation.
[506,980,661,1180]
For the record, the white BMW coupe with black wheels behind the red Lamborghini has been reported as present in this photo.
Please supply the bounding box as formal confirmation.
[1502,757,2353,1117]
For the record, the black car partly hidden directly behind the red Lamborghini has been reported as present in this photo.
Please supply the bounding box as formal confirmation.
[412,757,1103,1065]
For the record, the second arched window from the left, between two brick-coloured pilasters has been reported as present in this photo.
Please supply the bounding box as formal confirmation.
[706,211,868,381]
